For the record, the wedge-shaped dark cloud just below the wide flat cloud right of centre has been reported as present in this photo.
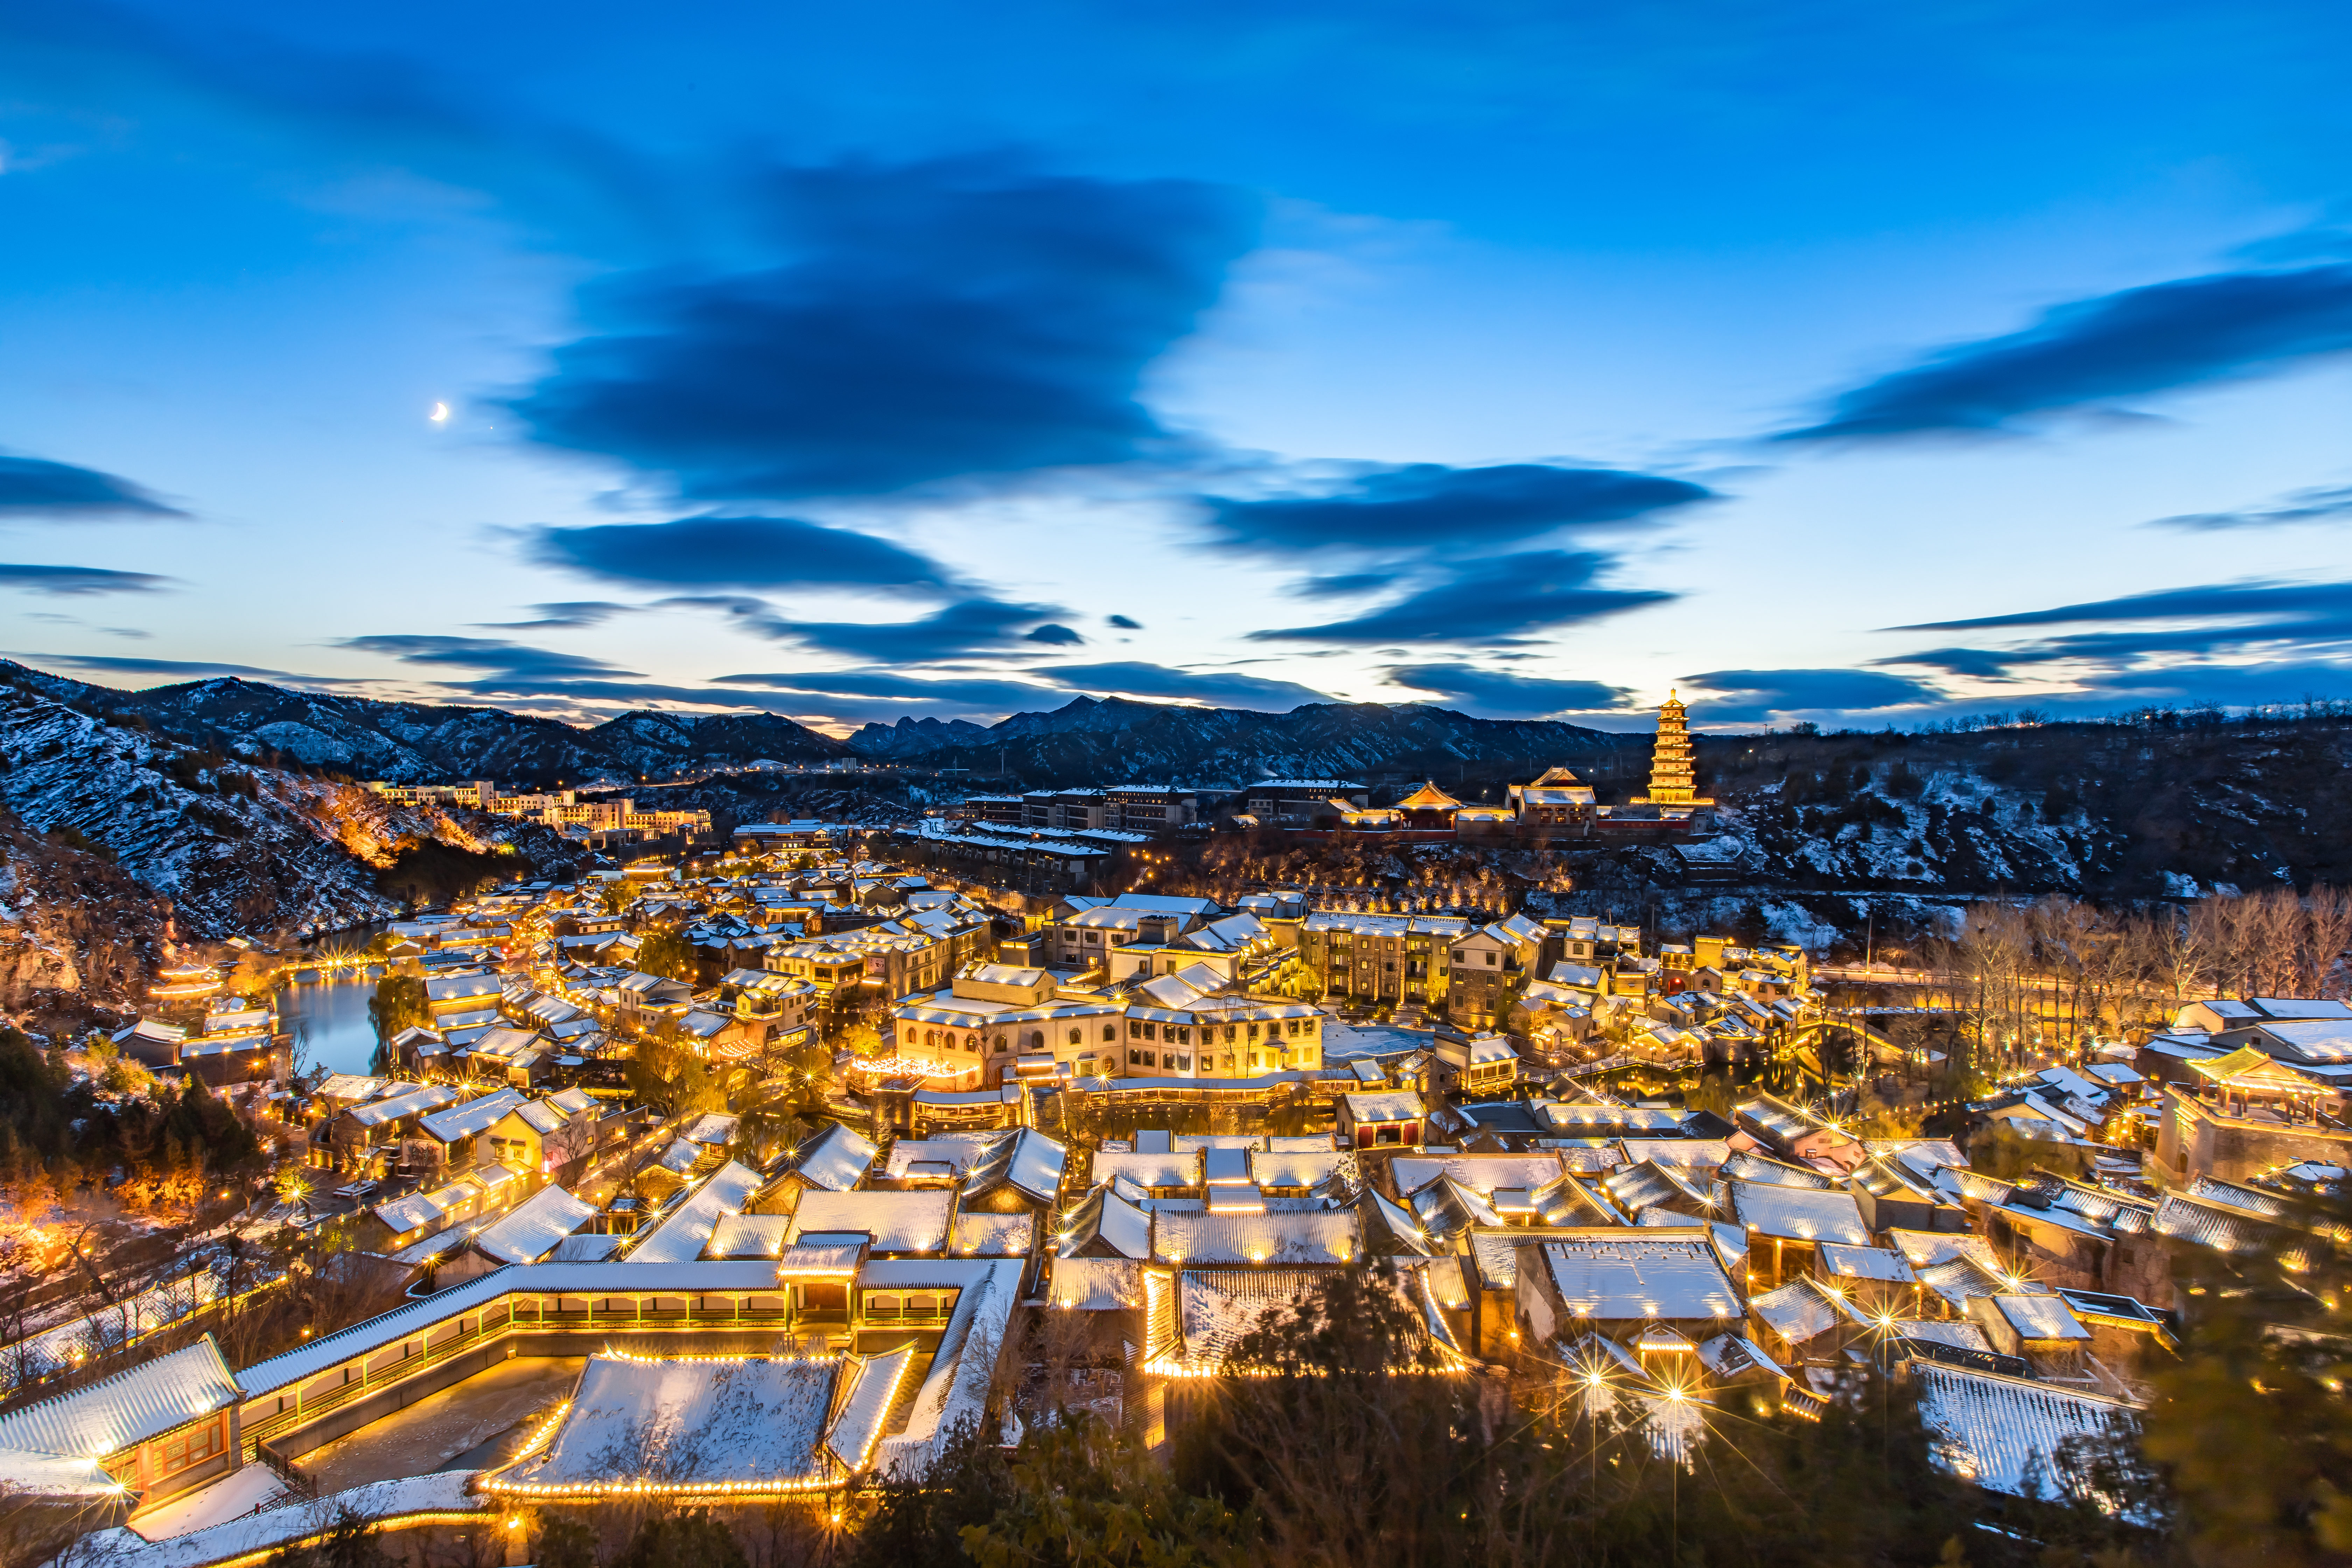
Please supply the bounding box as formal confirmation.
[1249,550,1675,642]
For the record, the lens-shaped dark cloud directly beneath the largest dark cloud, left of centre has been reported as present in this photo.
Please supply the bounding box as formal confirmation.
[532,517,955,593]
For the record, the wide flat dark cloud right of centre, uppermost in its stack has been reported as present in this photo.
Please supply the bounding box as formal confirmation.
[1204,463,1715,555]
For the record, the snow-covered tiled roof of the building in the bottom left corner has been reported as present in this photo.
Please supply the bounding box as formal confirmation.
[0,1333,240,1493]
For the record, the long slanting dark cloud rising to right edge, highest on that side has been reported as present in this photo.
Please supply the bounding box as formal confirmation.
[1776,266,2352,442]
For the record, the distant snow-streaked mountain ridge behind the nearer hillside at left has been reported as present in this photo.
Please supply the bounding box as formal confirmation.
[0,660,849,785]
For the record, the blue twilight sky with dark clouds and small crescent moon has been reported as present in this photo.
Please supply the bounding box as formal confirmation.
[0,0,2352,734]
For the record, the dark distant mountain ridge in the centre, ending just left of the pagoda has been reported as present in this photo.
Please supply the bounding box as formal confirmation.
[849,696,1618,788]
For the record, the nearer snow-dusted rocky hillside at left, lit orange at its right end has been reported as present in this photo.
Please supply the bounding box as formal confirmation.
[0,686,574,938]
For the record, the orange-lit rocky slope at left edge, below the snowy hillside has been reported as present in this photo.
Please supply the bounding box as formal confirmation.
[0,809,174,1032]
